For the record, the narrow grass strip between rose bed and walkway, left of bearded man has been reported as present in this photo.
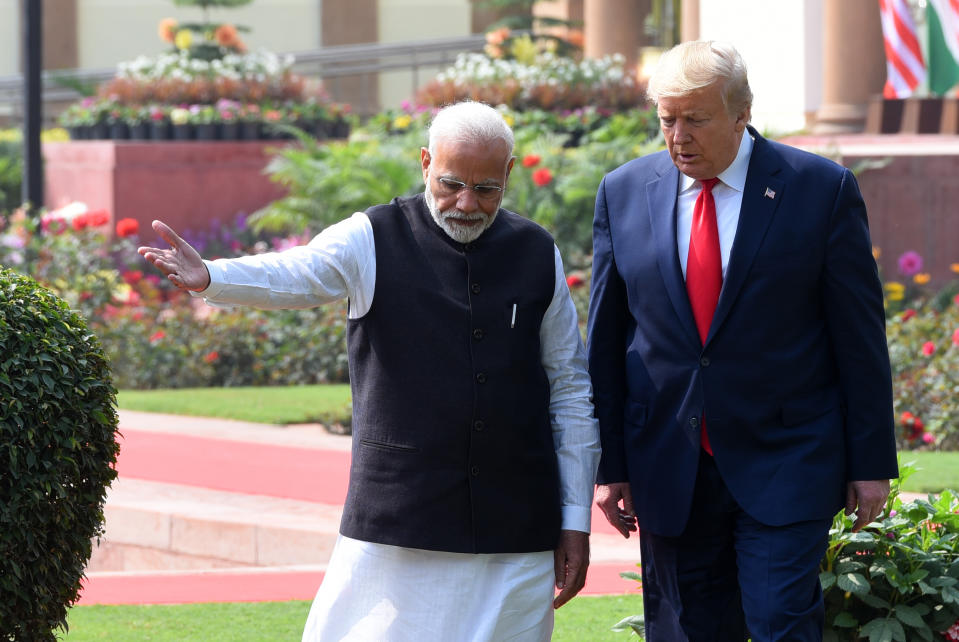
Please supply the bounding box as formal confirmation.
[117,384,352,425]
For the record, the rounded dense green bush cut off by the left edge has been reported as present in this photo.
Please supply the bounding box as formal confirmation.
[0,268,119,640]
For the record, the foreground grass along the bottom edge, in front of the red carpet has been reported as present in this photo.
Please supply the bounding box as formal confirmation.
[63,593,643,642]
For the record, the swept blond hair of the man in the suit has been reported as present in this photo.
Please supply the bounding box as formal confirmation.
[646,40,753,114]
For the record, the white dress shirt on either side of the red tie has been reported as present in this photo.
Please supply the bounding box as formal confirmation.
[676,132,753,280]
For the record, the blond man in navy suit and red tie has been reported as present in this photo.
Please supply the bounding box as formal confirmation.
[588,41,898,642]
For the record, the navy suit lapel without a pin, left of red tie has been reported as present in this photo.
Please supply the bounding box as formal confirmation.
[646,162,700,344]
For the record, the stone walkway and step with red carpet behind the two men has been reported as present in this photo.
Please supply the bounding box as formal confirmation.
[79,410,639,605]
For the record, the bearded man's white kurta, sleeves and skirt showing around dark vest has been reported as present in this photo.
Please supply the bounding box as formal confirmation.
[200,212,600,642]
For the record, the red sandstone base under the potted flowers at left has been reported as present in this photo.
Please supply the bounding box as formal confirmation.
[43,140,284,238]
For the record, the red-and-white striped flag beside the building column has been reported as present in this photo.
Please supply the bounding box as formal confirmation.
[879,0,926,98]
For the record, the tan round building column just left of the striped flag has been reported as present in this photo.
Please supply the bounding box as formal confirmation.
[813,0,886,134]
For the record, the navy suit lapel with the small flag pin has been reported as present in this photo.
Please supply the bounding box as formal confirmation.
[706,127,785,344]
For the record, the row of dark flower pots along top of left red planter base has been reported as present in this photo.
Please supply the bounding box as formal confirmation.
[59,98,350,140]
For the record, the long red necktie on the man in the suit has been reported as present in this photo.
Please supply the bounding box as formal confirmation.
[686,178,723,455]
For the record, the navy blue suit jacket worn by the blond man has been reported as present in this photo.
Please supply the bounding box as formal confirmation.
[588,128,898,536]
